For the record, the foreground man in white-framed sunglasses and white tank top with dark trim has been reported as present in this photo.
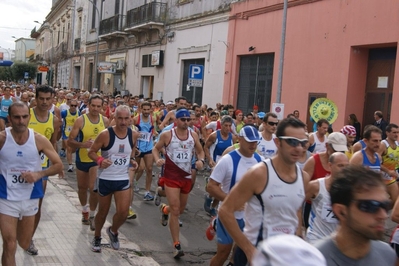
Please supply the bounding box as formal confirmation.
[219,118,309,265]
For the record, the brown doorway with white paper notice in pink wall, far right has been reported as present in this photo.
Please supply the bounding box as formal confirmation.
[362,47,397,128]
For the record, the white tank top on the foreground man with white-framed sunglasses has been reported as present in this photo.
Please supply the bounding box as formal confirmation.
[244,159,305,246]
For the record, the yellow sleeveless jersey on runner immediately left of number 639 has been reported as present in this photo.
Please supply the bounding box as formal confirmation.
[76,114,105,163]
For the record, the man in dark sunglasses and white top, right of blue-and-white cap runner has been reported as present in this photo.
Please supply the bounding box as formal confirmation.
[258,113,278,158]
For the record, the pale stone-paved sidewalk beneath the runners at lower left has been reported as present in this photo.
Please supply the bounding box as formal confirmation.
[5,176,159,266]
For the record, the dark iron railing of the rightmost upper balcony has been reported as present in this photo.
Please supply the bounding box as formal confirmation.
[126,2,167,28]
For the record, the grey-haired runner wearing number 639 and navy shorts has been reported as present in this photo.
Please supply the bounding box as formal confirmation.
[88,105,139,252]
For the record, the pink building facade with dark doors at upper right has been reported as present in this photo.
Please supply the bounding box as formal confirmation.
[223,0,399,130]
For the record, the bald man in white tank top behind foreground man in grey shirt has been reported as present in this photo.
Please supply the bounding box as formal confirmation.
[306,152,349,244]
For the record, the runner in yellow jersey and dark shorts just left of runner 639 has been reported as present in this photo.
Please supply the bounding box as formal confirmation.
[68,94,108,231]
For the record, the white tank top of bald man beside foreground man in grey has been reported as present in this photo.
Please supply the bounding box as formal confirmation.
[306,178,338,243]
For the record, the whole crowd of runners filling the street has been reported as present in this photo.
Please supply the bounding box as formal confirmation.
[0,82,399,266]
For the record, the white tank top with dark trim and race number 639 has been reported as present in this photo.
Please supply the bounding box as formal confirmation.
[98,127,132,181]
